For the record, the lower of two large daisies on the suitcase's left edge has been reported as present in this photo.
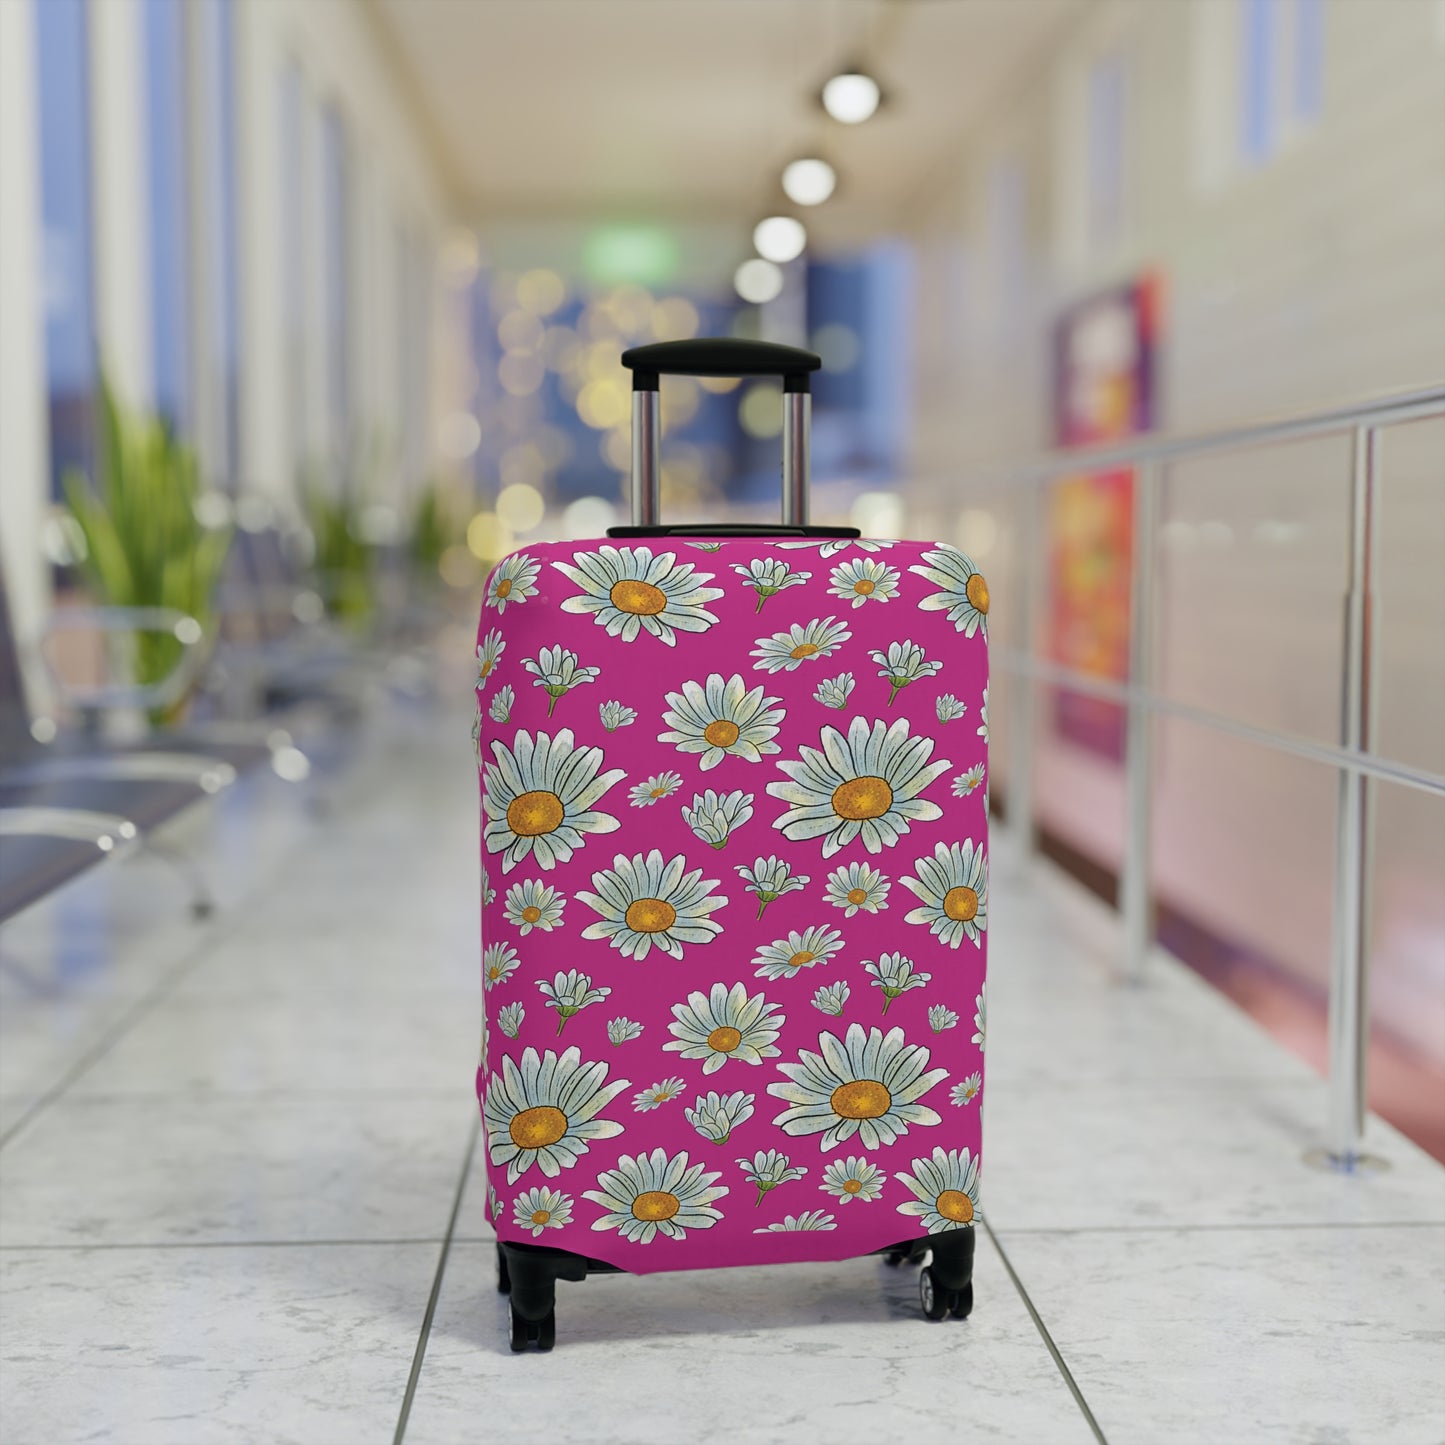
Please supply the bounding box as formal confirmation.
[483,1049,629,1183]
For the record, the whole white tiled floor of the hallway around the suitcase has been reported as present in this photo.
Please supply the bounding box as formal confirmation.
[0,702,1445,1445]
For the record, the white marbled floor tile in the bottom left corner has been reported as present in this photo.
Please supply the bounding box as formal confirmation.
[0,1244,438,1445]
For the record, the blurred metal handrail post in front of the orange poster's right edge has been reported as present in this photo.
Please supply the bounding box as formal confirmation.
[1118,461,1160,984]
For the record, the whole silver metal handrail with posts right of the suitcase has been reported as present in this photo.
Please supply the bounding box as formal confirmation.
[984,383,1445,1170]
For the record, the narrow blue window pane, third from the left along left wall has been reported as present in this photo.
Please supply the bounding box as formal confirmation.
[192,0,240,486]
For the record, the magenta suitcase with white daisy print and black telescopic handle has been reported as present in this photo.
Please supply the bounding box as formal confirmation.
[473,341,988,1351]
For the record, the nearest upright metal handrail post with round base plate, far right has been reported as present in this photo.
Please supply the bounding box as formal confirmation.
[1325,426,1379,1172]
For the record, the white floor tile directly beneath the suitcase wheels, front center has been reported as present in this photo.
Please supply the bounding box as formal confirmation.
[406,1241,1092,1445]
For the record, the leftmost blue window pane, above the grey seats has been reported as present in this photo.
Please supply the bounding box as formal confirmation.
[35,0,97,497]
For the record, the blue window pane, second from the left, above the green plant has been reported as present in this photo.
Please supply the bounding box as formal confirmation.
[145,0,191,432]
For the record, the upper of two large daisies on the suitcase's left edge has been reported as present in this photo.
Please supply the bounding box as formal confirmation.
[483,728,623,873]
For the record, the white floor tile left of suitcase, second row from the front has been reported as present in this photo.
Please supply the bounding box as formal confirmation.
[0,1094,475,1246]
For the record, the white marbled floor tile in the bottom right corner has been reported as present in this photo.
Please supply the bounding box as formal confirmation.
[1000,1228,1445,1445]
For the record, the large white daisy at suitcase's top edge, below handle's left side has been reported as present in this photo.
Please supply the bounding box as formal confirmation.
[552,546,723,647]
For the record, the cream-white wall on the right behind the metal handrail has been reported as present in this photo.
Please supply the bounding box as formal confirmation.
[909,0,1445,1058]
